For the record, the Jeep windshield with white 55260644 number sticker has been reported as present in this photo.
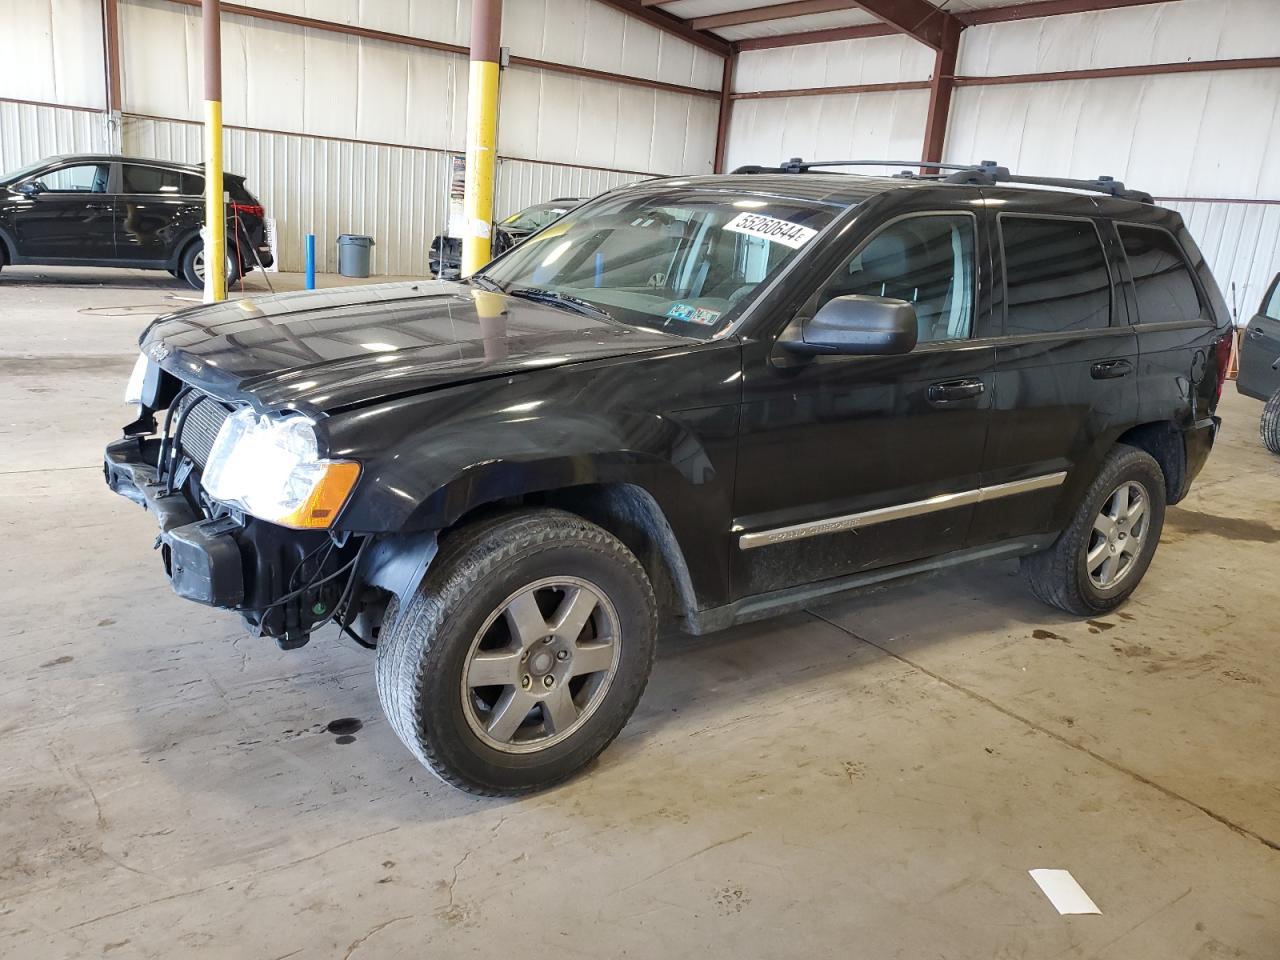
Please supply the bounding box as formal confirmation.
[484,187,838,339]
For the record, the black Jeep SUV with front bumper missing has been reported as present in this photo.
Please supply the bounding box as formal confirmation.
[106,165,1230,794]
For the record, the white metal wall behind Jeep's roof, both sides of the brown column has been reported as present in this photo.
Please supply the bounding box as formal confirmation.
[727,0,1280,316]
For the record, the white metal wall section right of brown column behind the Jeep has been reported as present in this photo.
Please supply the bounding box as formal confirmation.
[943,0,1280,312]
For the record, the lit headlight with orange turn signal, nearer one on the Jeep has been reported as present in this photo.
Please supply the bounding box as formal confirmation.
[202,408,360,530]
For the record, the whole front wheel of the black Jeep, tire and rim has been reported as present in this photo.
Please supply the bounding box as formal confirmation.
[375,509,658,796]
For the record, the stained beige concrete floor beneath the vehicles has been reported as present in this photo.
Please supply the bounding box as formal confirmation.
[0,264,1280,960]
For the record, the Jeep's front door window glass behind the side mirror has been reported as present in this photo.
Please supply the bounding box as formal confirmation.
[815,214,974,343]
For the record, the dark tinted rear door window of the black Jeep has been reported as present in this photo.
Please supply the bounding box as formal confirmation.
[1000,215,1111,335]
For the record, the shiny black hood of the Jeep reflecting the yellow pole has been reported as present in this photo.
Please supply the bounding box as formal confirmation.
[140,280,694,411]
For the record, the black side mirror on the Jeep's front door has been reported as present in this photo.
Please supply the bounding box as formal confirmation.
[778,293,919,356]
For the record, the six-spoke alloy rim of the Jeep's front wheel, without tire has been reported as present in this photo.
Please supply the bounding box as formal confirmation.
[462,576,622,753]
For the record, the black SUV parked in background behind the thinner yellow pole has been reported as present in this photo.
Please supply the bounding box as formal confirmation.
[0,154,271,288]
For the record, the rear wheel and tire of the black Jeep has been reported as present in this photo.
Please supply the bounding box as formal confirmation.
[1021,444,1165,617]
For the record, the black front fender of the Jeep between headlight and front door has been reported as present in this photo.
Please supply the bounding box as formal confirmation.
[325,343,740,595]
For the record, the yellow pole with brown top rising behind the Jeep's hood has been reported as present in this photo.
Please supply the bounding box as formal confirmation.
[462,0,502,276]
